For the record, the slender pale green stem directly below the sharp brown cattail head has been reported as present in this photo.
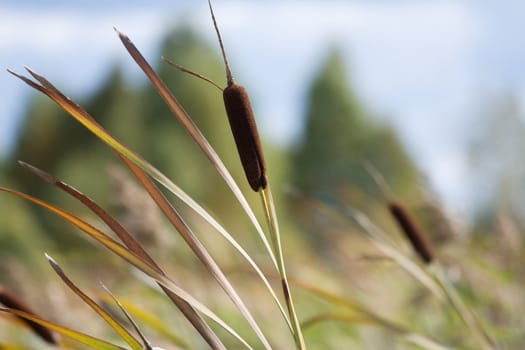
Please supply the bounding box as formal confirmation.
[260,186,306,350]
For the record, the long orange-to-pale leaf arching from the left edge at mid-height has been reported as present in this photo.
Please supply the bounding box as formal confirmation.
[0,187,252,349]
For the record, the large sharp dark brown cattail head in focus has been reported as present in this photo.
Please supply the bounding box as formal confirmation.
[223,83,268,192]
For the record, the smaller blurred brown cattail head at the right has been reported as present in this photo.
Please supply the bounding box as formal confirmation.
[388,202,434,264]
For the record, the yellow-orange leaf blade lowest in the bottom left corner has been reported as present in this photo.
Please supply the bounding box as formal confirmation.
[0,307,126,350]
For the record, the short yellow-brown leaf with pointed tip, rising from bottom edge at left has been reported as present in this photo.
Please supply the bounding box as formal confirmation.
[46,254,142,350]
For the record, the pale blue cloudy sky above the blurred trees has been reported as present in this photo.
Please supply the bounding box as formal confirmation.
[0,0,525,217]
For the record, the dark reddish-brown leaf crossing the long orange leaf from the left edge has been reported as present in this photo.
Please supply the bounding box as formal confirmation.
[15,163,224,349]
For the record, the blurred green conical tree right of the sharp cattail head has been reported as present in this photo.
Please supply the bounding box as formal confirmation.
[293,50,418,204]
